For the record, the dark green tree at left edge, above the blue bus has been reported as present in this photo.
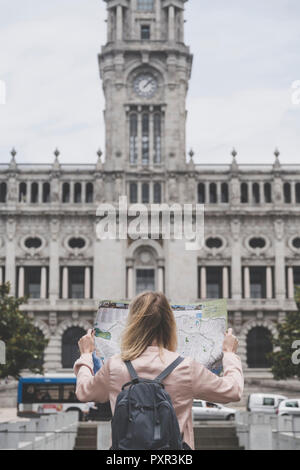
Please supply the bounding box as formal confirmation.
[0,283,48,379]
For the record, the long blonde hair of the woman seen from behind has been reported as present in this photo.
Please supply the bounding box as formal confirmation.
[121,292,177,361]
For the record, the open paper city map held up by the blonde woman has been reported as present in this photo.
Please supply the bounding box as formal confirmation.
[94,300,227,374]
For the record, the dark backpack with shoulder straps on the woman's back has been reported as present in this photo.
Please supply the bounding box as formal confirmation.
[112,357,184,450]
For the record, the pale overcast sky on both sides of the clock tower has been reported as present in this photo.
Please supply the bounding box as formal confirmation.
[0,0,300,163]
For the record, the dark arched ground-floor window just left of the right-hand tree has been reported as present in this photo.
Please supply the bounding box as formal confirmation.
[247,326,273,369]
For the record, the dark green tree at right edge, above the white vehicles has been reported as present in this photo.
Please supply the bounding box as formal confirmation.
[269,287,300,380]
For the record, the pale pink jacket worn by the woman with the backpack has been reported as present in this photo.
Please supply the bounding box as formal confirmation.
[74,346,244,449]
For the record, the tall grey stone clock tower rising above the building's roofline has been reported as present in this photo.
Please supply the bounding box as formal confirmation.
[99,0,192,172]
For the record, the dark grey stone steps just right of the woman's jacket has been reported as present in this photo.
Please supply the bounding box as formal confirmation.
[194,421,243,450]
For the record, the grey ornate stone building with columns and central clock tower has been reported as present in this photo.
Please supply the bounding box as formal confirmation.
[0,0,300,371]
